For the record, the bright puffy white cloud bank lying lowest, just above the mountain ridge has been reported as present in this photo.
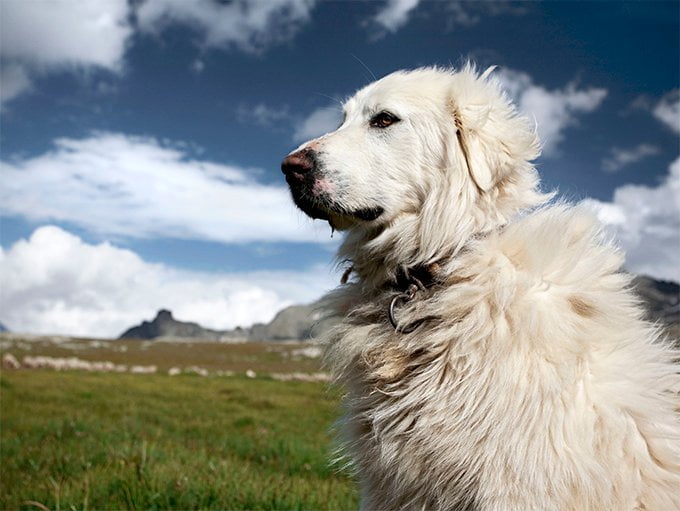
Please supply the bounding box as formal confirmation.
[0,226,337,337]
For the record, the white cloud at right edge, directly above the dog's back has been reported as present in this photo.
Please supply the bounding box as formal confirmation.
[583,158,680,282]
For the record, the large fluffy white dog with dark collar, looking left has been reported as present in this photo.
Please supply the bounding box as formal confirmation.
[282,66,680,511]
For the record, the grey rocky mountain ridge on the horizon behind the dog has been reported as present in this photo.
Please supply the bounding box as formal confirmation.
[120,276,680,344]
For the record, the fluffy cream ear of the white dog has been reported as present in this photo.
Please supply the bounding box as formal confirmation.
[451,68,540,192]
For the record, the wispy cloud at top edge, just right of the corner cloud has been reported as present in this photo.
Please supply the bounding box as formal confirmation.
[137,0,316,51]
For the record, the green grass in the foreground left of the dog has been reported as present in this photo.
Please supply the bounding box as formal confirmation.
[0,370,357,511]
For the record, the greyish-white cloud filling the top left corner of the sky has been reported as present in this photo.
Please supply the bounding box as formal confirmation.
[0,0,132,106]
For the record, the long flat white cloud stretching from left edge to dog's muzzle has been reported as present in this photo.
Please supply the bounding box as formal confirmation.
[0,133,329,242]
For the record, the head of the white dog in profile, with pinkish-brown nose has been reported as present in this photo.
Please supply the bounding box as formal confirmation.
[282,66,539,236]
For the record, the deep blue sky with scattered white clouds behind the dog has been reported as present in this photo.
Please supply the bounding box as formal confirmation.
[0,0,680,336]
